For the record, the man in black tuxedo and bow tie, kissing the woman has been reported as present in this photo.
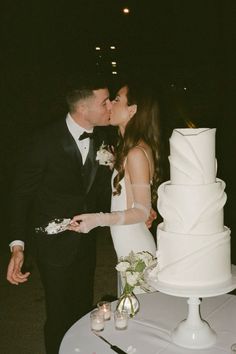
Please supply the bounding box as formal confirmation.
[7,73,114,354]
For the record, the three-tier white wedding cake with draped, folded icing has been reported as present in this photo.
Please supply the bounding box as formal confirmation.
[153,129,231,287]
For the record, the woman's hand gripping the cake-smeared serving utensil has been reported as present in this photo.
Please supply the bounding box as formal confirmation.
[68,214,101,233]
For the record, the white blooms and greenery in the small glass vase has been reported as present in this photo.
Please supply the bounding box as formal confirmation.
[116,251,157,294]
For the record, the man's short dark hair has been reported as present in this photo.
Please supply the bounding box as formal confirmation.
[66,74,108,112]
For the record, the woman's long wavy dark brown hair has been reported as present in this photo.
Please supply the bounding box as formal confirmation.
[113,82,162,205]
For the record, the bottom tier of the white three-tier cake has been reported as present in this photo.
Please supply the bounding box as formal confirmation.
[157,223,231,287]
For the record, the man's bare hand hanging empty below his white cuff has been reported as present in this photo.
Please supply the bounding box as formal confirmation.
[7,246,30,285]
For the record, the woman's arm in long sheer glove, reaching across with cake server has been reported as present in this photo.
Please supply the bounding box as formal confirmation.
[69,148,151,233]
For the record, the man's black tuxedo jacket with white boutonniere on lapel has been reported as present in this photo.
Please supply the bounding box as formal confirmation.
[10,120,111,262]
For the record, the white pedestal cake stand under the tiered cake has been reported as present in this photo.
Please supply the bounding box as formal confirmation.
[146,266,236,349]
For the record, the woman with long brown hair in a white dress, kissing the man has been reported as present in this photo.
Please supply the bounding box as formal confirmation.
[69,83,160,292]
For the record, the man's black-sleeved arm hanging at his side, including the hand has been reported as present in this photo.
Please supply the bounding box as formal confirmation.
[7,133,45,285]
